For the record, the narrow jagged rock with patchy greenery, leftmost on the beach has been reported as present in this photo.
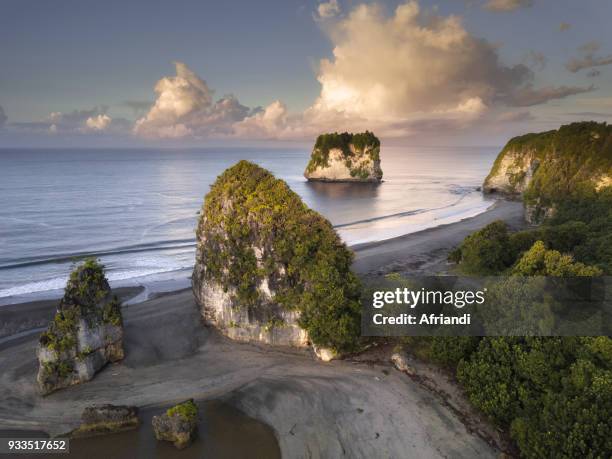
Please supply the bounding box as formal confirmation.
[37,260,123,394]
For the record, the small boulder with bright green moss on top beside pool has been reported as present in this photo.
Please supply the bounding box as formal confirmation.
[152,400,198,449]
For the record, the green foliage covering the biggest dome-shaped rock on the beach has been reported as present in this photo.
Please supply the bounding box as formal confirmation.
[196,161,361,351]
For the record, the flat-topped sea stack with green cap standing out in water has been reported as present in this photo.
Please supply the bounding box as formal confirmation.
[304,131,383,182]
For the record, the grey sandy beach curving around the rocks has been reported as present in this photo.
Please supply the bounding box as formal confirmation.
[0,202,522,458]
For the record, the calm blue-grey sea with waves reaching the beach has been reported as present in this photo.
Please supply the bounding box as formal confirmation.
[0,147,498,304]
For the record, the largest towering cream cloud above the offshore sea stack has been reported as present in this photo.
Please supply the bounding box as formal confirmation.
[311,1,592,125]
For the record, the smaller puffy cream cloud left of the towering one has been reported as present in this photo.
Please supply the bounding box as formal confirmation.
[134,62,254,138]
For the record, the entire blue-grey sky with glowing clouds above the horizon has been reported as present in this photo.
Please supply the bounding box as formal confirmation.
[0,0,612,148]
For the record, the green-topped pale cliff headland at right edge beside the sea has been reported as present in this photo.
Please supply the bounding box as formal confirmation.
[483,122,612,223]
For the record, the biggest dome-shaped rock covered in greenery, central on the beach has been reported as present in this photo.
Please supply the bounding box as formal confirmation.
[192,161,360,351]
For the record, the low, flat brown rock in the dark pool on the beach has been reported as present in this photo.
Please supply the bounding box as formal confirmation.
[70,405,140,437]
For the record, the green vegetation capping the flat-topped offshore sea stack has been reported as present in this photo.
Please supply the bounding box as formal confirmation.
[306,131,380,173]
